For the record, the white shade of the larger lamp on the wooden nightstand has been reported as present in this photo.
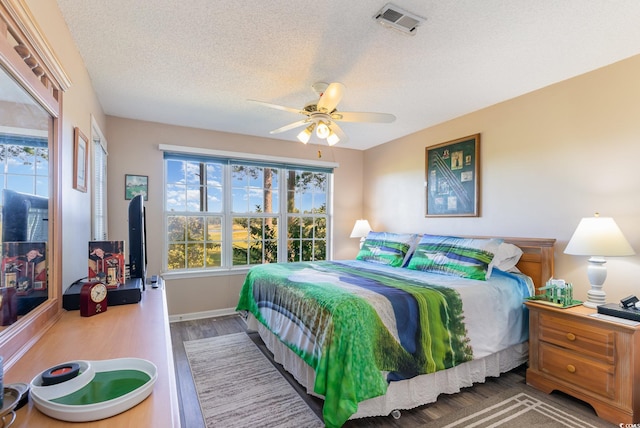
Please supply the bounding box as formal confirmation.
[564,215,635,257]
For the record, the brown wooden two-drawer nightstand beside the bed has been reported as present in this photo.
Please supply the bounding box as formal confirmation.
[526,302,640,424]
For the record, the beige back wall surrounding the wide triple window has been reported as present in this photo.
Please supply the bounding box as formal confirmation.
[106,116,363,315]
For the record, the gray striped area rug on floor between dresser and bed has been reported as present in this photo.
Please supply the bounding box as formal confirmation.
[184,333,324,428]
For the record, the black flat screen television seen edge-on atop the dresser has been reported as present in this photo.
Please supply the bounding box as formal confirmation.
[129,195,147,290]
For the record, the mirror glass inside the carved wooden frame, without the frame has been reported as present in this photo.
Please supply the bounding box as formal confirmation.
[0,59,53,331]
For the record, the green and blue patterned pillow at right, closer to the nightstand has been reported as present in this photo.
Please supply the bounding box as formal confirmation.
[407,235,502,281]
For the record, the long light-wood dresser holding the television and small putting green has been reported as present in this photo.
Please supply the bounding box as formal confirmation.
[4,282,180,428]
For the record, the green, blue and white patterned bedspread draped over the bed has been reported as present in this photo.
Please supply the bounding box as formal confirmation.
[237,261,472,427]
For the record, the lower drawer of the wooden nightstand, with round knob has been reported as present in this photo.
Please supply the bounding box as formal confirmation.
[539,343,616,399]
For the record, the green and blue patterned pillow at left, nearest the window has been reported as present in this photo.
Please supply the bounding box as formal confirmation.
[356,232,418,267]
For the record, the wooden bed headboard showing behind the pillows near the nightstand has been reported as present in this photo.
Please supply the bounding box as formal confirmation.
[502,238,556,294]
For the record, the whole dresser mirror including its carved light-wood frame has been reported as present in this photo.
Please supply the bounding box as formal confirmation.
[0,0,70,370]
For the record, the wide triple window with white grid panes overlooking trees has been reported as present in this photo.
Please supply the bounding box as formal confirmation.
[165,153,332,271]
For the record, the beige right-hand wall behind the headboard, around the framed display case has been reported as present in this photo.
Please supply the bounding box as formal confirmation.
[364,56,640,301]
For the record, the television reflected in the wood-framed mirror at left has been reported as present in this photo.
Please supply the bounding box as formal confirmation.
[2,189,49,242]
